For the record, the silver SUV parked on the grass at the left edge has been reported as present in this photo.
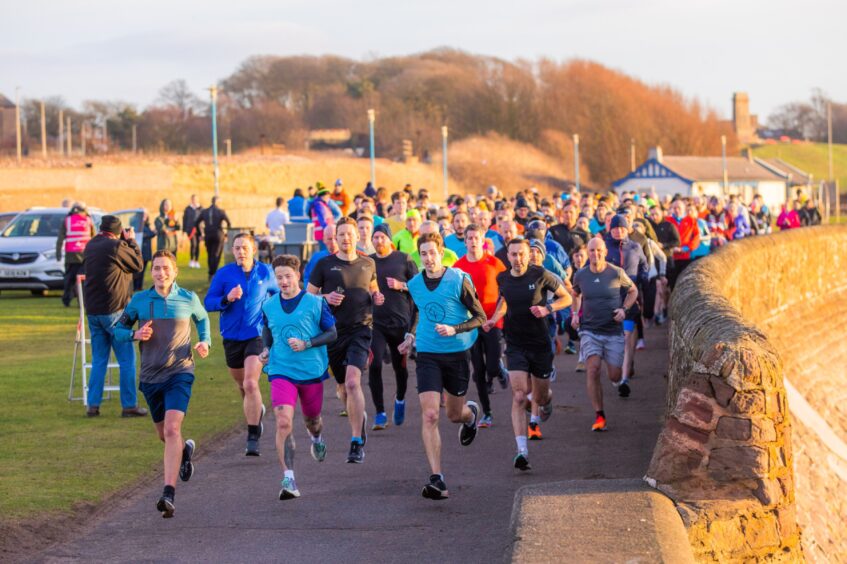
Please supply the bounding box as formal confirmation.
[0,207,103,295]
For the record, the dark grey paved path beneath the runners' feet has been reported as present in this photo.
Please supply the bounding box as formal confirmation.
[40,329,667,562]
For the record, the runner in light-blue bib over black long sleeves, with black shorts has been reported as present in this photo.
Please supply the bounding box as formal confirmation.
[399,233,485,500]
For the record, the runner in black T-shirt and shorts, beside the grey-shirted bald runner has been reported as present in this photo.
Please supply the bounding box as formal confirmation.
[484,238,571,470]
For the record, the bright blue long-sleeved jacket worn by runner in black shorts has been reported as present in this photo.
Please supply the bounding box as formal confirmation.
[203,262,279,341]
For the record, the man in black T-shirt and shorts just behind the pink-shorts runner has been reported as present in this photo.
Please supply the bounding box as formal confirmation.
[308,217,385,464]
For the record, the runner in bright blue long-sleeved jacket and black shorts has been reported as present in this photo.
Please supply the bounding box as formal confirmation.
[203,233,279,456]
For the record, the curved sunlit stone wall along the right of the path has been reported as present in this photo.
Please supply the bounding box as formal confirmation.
[645,227,847,561]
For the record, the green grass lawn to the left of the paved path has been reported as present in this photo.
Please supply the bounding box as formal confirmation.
[0,253,243,521]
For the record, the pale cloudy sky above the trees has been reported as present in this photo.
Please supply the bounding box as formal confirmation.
[0,0,847,121]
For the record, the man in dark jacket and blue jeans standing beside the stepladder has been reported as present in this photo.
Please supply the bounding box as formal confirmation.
[83,215,147,417]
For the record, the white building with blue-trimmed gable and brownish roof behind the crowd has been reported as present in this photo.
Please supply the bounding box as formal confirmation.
[612,147,788,210]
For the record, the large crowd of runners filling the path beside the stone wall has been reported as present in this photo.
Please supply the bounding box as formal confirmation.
[69,180,819,517]
